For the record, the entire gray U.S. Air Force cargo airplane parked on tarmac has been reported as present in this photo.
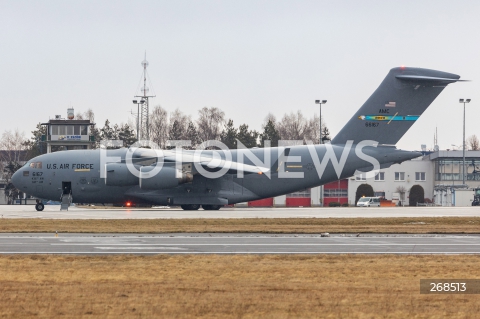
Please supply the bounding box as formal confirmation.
[12,67,460,211]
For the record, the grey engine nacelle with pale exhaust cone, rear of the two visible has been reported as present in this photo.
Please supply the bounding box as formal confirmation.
[139,166,193,189]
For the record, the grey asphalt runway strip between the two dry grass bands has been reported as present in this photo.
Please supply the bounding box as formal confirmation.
[0,234,480,255]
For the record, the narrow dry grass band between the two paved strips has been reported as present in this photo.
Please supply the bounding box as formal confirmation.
[0,217,480,234]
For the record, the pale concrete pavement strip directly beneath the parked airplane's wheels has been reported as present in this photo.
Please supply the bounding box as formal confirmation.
[0,205,480,219]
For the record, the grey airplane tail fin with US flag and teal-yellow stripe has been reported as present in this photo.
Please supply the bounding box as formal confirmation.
[331,67,462,145]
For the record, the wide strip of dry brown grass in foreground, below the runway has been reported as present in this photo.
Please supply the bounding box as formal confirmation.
[0,255,480,318]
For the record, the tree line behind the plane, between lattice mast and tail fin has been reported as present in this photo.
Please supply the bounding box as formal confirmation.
[150,105,329,148]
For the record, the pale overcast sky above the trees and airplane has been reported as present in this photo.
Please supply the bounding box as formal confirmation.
[0,0,480,150]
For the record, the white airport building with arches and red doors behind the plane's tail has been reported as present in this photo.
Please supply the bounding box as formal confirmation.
[248,150,480,207]
